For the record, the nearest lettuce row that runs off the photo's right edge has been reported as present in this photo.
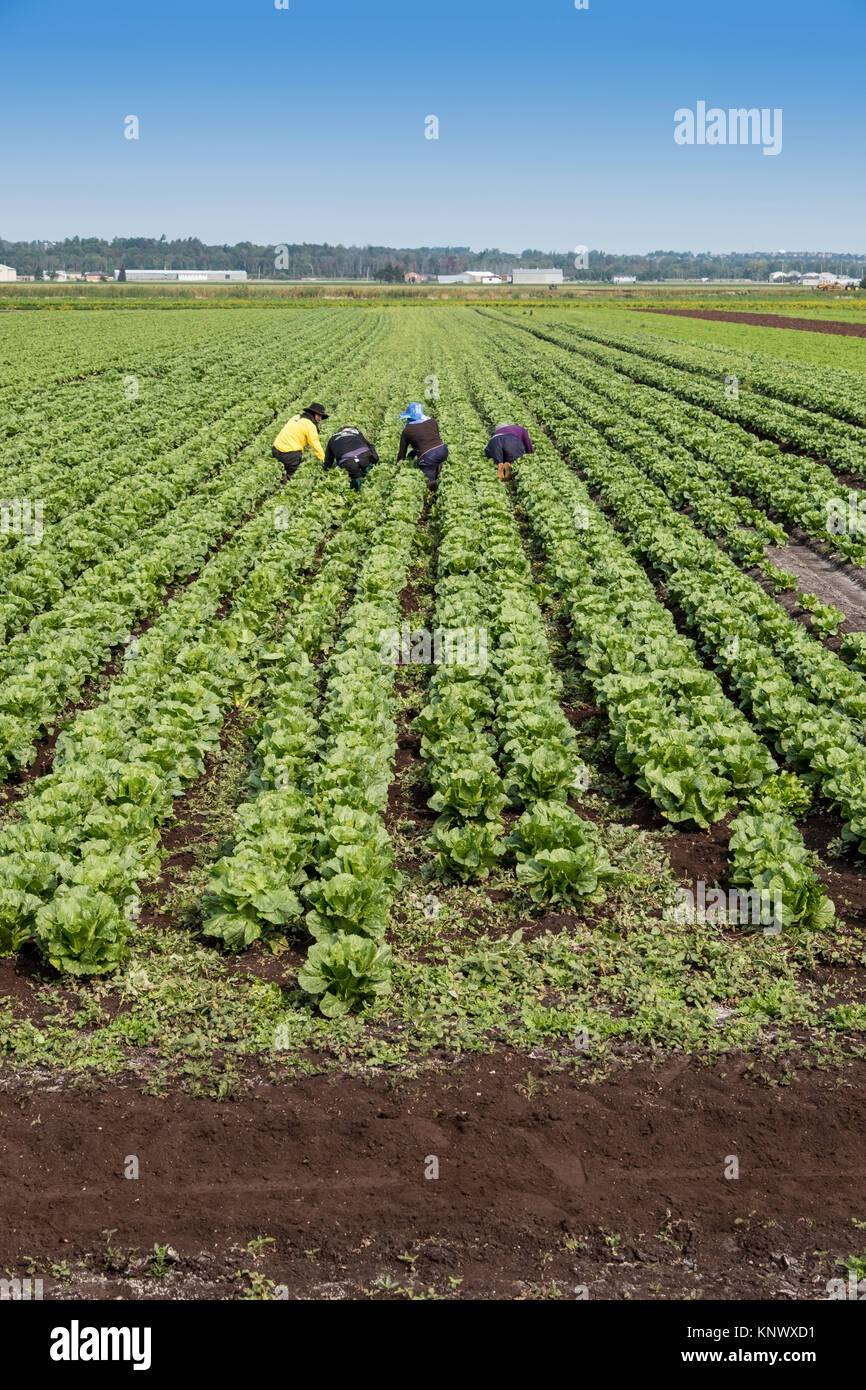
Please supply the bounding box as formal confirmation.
[480,318,866,853]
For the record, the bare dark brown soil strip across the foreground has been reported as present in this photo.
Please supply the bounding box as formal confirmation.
[0,1050,866,1300]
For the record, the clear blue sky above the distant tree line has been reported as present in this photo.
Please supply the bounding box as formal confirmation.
[0,0,866,252]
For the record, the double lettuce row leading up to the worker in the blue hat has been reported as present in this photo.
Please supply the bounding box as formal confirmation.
[204,463,425,1016]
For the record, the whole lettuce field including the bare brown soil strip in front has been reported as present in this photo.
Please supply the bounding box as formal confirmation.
[0,300,866,1298]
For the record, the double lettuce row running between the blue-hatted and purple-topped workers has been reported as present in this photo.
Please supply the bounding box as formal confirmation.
[414,383,616,906]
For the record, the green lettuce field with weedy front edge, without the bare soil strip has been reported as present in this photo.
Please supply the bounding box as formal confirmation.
[0,304,866,1088]
